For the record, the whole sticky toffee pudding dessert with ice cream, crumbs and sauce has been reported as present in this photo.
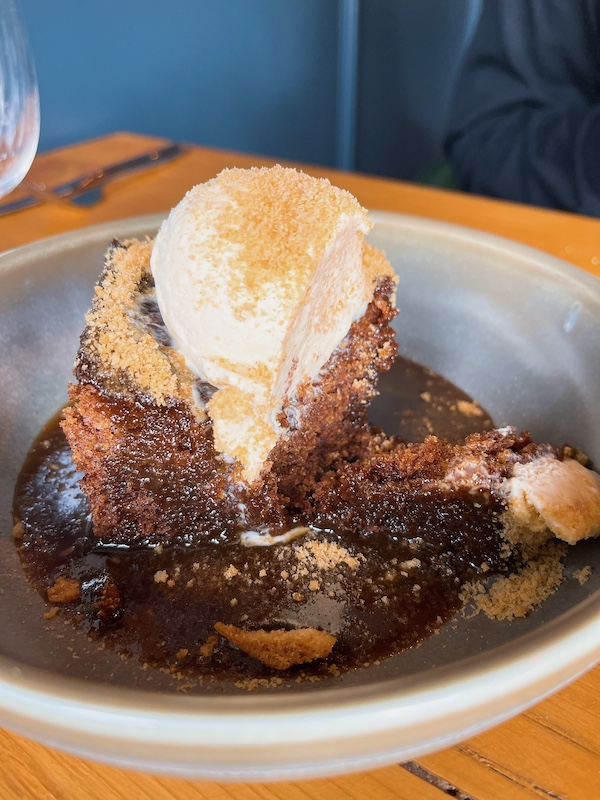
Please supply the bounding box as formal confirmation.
[14,167,600,687]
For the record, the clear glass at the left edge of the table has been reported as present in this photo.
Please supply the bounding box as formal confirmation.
[0,0,40,197]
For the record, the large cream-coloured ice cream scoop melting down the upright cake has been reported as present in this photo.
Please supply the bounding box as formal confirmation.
[151,166,394,482]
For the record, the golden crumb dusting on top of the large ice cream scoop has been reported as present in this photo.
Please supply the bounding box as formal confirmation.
[169,166,371,317]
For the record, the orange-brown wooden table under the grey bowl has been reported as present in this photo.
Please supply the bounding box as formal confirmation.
[0,133,600,800]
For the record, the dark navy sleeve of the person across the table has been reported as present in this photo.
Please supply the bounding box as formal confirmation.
[445,0,600,216]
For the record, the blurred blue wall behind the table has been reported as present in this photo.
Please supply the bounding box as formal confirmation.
[20,0,481,182]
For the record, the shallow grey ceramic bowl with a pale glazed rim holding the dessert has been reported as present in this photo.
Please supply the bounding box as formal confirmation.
[0,213,600,780]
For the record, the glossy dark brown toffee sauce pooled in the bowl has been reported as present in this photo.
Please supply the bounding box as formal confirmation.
[13,358,502,683]
